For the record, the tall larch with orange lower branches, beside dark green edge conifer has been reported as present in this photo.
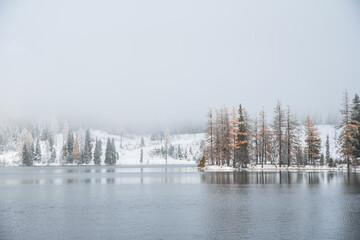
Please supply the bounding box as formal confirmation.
[338,90,357,170]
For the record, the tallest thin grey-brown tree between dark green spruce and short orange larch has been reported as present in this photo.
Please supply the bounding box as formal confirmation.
[272,100,286,167]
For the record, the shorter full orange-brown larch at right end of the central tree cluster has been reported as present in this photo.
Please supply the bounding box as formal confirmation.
[305,115,321,164]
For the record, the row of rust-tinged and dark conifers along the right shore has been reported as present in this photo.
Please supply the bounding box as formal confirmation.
[204,91,360,167]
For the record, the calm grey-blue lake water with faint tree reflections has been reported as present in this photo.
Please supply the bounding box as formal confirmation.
[0,166,360,239]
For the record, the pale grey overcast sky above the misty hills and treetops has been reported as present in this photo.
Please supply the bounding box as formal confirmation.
[0,0,360,130]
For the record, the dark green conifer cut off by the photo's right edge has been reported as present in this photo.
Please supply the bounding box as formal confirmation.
[351,94,360,159]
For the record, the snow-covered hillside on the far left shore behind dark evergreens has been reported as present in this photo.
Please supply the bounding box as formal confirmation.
[0,130,204,166]
